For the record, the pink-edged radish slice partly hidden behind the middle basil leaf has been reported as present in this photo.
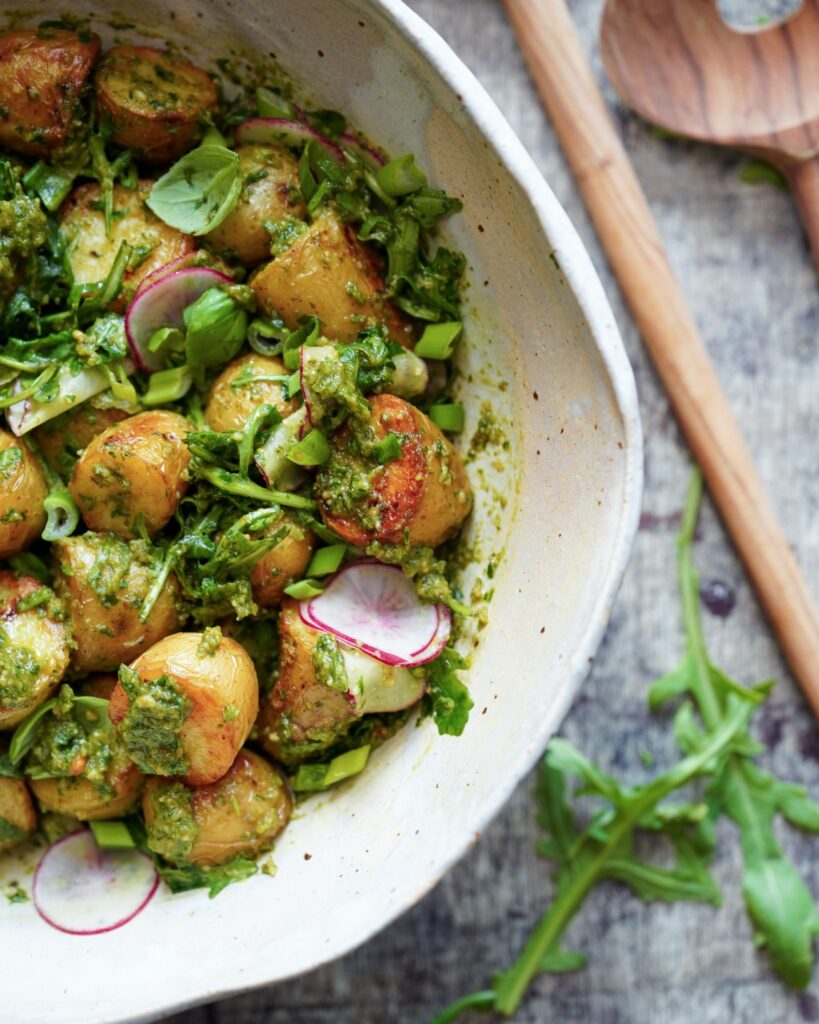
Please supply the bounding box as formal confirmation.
[125,266,234,373]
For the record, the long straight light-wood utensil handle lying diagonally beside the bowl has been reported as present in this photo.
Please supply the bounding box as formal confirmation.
[504,0,819,717]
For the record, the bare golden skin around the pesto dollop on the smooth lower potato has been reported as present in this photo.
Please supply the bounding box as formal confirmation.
[109,633,259,785]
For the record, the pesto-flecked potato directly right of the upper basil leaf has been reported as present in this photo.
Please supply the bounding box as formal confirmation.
[206,145,307,266]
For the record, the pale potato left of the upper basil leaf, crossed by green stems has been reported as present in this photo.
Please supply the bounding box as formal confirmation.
[59,181,195,310]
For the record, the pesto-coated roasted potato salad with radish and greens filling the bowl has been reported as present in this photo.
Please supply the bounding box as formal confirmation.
[0,20,472,909]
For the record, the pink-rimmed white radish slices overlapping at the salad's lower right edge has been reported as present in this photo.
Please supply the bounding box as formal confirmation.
[299,561,444,667]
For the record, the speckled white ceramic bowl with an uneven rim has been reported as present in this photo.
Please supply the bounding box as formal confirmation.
[0,0,642,1024]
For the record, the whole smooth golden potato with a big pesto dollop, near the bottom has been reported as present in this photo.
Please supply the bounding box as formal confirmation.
[109,627,259,785]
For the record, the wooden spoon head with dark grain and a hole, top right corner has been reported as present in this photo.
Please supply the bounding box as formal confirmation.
[600,0,819,265]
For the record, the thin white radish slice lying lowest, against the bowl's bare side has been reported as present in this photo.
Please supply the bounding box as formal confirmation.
[32,829,160,935]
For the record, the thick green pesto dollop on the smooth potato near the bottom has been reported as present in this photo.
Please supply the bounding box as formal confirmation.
[118,665,190,775]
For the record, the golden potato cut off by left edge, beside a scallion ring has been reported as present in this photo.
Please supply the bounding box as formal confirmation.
[0,430,48,558]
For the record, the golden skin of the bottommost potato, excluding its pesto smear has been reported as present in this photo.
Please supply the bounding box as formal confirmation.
[142,749,293,867]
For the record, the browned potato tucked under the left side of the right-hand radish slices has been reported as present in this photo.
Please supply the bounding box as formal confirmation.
[258,597,354,765]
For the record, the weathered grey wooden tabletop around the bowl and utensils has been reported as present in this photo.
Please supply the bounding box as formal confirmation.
[164,0,819,1024]
